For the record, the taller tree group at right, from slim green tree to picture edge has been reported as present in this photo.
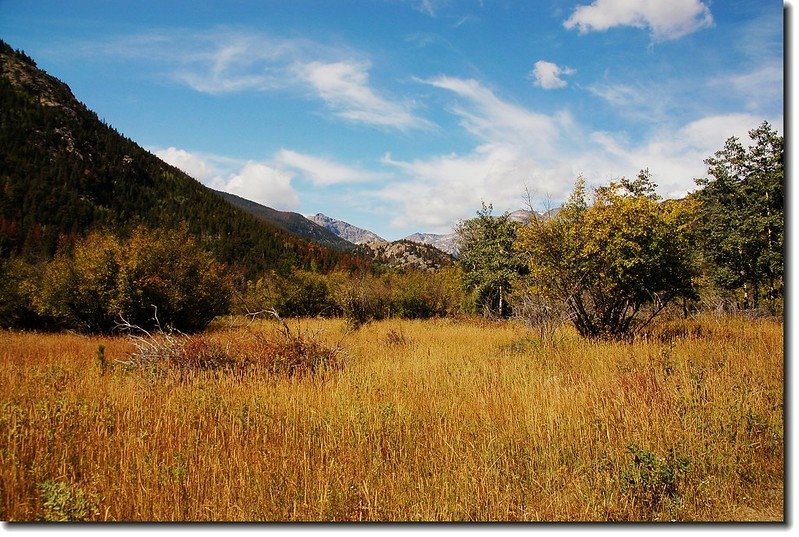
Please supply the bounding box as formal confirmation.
[459,122,785,339]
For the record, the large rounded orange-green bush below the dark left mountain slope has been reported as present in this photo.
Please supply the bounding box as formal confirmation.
[34,228,231,332]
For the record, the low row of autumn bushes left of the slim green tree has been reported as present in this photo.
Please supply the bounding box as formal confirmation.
[0,226,464,332]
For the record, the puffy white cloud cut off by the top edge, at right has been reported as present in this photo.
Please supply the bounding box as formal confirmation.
[563,0,713,41]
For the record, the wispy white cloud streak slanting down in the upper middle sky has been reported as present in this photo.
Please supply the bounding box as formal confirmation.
[295,61,431,130]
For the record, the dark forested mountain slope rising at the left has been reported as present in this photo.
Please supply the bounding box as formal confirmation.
[0,41,365,276]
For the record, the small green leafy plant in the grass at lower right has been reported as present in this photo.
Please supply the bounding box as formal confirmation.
[621,444,689,513]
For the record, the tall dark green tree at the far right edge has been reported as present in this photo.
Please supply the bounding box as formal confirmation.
[696,122,785,309]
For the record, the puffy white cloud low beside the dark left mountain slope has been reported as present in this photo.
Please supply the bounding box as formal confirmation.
[152,147,300,211]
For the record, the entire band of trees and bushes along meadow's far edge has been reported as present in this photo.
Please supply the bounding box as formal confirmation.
[0,123,784,339]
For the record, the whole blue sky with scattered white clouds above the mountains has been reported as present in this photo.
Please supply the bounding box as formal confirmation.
[0,0,784,240]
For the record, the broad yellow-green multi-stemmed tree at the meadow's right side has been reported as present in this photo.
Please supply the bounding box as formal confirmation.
[515,174,694,339]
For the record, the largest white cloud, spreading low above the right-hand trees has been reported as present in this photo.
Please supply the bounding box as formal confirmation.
[368,71,776,233]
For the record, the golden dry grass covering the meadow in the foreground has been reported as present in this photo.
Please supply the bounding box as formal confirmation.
[0,317,784,521]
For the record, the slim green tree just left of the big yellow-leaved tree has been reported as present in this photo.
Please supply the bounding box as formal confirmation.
[456,203,524,317]
